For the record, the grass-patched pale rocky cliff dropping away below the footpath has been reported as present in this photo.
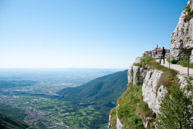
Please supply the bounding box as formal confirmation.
[109,57,193,129]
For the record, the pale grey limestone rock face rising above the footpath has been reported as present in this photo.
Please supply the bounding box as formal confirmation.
[171,0,193,60]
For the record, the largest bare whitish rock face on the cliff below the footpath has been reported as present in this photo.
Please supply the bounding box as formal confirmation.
[128,63,167,113]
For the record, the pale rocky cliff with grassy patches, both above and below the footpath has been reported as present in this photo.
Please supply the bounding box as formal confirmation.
[109,0,193,129]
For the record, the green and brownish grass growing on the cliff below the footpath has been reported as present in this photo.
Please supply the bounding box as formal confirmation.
[108,56,181,129]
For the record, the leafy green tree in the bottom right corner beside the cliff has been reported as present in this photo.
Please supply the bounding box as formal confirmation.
[156,82,193,129]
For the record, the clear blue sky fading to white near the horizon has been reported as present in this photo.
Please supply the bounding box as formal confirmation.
[0,0,188,68]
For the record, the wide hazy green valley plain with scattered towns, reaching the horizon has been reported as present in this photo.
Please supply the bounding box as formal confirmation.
[0,70,119,129]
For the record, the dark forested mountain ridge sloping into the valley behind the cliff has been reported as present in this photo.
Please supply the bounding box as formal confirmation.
[58,70,127,107]
